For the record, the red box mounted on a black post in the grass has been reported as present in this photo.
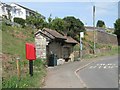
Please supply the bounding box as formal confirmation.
[25,43,36,60]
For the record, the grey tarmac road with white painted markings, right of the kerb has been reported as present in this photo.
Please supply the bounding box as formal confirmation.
[78,56,118,88]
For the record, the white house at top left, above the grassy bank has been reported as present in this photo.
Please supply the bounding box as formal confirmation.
[0,2,45,22]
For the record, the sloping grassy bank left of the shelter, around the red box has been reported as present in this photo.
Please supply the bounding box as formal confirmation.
[2,23,46,88]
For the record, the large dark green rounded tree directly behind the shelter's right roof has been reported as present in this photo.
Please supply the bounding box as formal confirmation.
[63,16,85,41]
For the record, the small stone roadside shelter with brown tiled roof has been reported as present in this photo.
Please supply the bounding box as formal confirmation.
[35,28,78,61]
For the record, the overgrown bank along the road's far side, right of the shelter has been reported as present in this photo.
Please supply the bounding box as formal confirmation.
[74,31,118,60]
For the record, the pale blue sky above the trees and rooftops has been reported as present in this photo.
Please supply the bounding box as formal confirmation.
[3,0,118,28]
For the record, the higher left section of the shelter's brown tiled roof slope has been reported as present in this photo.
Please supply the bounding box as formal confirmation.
[43,28,66,40]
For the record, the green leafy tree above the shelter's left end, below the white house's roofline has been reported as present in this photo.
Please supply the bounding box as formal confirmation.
[26,12,46,29]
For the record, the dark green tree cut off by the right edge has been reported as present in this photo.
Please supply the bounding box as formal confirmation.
[114,18,120,46]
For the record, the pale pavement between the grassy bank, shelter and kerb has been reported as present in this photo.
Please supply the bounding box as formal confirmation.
[43,61,92,88]
